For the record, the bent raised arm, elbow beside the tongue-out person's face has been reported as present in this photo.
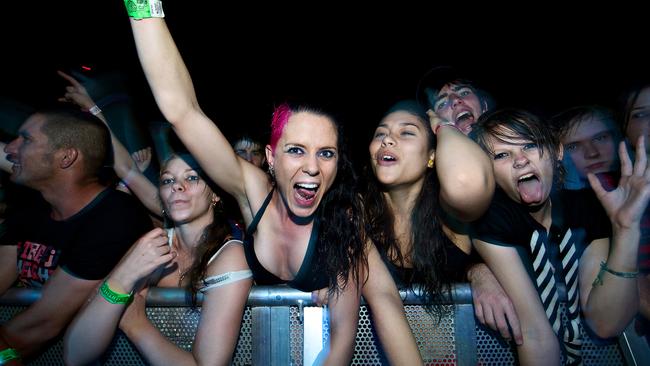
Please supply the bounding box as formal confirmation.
[427,110,495,222]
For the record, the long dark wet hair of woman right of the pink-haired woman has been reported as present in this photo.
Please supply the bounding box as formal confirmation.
[364,101,453,318]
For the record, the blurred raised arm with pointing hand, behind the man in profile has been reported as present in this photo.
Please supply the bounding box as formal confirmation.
[57,71,162,215]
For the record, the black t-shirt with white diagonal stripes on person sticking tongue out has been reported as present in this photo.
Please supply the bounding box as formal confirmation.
[471,189,611,364]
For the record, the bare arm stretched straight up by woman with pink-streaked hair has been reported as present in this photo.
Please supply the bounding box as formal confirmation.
[126,14,270,203]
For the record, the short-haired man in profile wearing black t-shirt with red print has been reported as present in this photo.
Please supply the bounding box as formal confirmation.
[0,110,151,364]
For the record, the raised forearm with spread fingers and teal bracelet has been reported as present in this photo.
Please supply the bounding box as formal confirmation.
[580,138,650,337]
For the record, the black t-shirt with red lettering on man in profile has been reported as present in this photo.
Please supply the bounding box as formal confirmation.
[0,188,152,287]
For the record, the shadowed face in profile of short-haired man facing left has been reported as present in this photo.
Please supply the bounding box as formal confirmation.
[5,114,56,189]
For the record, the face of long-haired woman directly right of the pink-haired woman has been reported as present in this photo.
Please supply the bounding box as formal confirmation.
[369,111,434,187]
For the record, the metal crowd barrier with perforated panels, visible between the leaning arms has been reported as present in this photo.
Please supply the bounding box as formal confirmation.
[0,284,639,366]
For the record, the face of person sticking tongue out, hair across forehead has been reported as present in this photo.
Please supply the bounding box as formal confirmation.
[487,131,561,206]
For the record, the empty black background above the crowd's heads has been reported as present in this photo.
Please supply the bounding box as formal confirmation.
[0,0,650,162]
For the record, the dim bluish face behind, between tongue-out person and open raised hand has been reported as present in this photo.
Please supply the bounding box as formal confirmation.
[562,115,617,178]
